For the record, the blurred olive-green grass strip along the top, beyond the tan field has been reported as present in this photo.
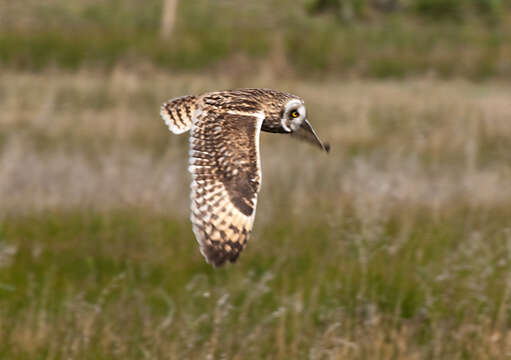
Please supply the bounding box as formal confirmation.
[0,0,511,80]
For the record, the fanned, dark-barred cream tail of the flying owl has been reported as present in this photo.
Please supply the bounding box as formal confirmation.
[160,96,197,134]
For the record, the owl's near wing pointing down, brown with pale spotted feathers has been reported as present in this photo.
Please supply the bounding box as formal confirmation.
[189,109,264,266]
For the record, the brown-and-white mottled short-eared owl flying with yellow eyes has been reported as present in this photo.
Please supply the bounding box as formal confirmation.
[160,89,329,266]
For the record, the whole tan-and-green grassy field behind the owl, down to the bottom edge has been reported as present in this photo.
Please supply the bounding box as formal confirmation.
[0,69,511,359]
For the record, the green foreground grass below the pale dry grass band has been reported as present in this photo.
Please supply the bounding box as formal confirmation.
[0,208,511,359]
